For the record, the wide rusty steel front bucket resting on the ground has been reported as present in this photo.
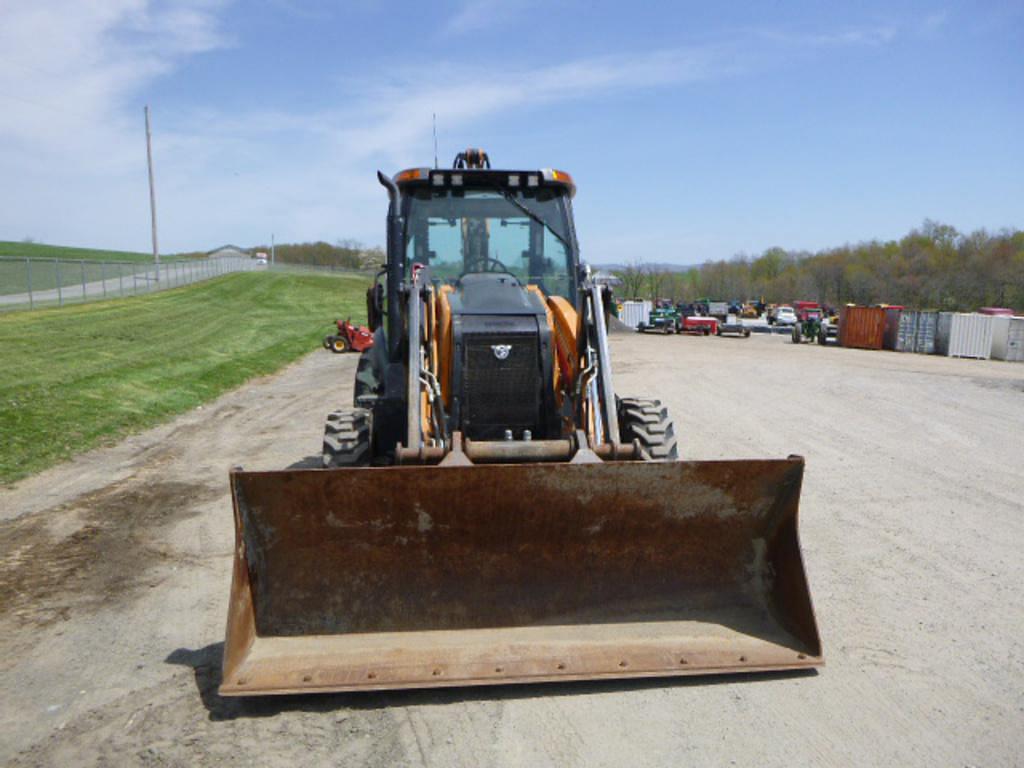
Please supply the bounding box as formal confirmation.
[220,458,822,695]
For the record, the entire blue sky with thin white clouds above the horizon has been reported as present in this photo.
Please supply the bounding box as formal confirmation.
[0,0,1024,263]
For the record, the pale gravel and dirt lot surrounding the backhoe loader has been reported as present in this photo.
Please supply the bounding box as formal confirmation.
[0,335,1024,767]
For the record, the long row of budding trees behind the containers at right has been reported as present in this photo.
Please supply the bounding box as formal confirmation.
[615,220,1024,310]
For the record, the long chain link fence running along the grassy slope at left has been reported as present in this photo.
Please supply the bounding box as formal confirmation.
[0,256,266,311]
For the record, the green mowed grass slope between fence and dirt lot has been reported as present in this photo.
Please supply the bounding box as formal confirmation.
[0,272,367,483]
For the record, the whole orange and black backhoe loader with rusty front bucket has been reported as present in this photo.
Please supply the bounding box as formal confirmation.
[220,150,823,696]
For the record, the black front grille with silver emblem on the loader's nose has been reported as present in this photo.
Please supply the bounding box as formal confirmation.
[463,333,542,440]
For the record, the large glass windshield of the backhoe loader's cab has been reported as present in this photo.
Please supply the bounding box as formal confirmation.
[406,187,574,300]
